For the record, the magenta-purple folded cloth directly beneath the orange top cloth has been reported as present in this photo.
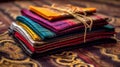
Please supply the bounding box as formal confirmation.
[21,9,108,34]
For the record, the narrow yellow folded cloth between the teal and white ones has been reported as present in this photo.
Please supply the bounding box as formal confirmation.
[17,22,41,41]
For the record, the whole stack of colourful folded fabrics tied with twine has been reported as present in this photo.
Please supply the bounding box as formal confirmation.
[9,5,115,55]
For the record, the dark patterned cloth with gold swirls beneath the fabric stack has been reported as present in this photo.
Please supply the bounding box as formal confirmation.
[0,0,120,67]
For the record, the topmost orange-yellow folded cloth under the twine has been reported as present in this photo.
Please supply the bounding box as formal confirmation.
[29,6,96,20]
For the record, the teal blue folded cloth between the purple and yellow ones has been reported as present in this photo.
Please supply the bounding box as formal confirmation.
[16,16,56,40]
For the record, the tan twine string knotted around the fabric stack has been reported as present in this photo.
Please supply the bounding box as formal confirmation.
[44,4,93,42]
